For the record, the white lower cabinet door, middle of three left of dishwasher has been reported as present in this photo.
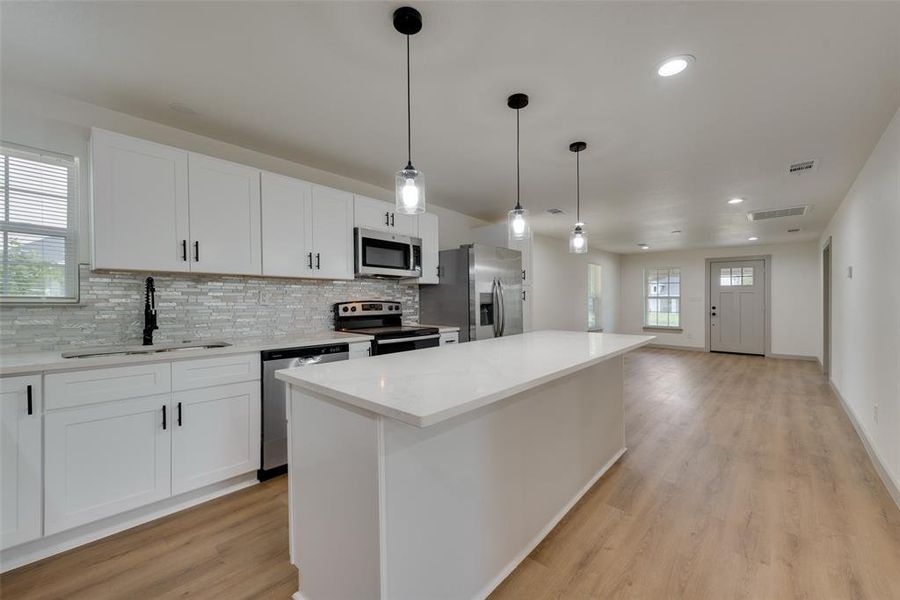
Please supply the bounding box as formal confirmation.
[44,394,173,535]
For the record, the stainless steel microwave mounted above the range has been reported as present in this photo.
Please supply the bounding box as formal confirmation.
[353,227,422,278]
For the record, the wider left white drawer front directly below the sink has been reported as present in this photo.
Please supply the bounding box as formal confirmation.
[44,363,172,410]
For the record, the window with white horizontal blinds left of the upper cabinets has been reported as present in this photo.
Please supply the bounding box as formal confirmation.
[0,145,78,303]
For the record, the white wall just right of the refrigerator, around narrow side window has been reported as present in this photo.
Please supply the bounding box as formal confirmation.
[531,235,621,332]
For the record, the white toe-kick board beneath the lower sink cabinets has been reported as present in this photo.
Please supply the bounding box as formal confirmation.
[0,471,259,573]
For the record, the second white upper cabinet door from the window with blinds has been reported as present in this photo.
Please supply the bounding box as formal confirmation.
[188,154,262,275]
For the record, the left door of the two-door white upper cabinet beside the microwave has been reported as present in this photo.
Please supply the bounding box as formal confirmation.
[261,173,312,277]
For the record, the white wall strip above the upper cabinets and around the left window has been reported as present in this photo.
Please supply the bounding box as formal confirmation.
[0,79,484,262]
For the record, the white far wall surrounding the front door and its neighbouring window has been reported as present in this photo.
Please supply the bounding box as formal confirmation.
[620,242,821,357]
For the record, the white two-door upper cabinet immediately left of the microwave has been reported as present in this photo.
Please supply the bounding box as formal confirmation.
[262,173,353,279]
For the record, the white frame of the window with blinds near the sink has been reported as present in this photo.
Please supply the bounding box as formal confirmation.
[0,139,81,306]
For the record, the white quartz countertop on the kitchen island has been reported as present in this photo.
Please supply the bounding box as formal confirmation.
[275,331,654,427]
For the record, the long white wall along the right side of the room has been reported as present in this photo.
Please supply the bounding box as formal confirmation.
[821,110,900,502]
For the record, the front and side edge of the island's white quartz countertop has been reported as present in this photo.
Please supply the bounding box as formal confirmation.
[275,335,656,428]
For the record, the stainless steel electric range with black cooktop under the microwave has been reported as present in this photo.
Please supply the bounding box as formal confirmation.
[334,300,441,356]
